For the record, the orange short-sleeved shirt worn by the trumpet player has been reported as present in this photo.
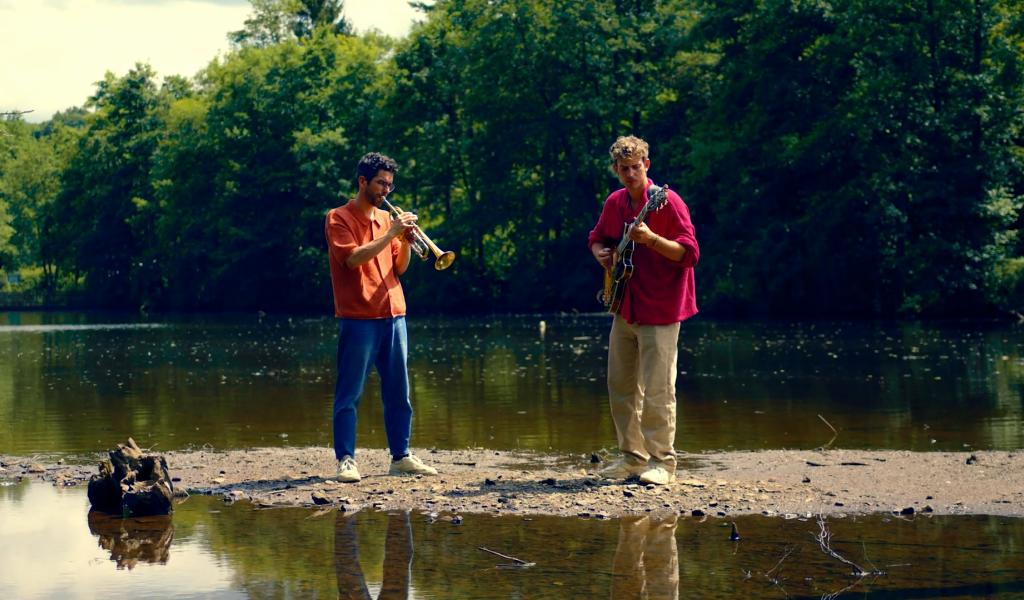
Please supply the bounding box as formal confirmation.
[324,200,406,318]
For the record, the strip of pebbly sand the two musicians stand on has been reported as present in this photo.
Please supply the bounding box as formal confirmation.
[0,447,1024,518]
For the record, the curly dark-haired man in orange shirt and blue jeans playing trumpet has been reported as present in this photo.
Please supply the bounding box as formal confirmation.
[325,153,437,482]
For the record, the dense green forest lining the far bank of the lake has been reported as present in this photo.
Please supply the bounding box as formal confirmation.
[0,0,1024,317]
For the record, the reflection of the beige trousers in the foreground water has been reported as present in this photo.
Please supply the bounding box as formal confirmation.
[611,515,679,600]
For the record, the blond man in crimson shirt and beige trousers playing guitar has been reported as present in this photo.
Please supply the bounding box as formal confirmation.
[588,135,700,484]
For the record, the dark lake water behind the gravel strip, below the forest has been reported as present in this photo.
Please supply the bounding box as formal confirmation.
[0,313,1024,456]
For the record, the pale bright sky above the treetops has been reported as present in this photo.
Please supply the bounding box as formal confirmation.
[0,0,422,123]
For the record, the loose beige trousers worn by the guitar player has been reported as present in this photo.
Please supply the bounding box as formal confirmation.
[608,314,679,473]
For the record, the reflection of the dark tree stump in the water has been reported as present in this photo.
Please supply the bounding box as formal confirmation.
[88,511,174,570]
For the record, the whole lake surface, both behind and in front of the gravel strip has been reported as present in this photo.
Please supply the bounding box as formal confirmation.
[0,312,1024,599]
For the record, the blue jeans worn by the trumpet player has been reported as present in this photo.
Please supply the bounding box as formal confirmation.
[334,316,413,461]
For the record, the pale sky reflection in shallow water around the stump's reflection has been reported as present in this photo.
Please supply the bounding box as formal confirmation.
[0,482,238,600]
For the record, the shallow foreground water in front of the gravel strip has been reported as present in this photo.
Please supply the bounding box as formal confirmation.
[0,483,1024,600]
